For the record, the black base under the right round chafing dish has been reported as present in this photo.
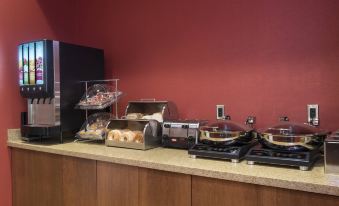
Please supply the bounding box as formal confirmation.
[245,144,321,171]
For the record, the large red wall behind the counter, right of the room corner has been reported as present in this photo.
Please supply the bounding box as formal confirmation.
[76,0,339,129]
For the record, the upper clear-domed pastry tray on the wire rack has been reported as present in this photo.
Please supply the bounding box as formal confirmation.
[76,84,122,109]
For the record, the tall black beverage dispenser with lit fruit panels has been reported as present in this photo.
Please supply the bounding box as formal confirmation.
[18,40,104,141]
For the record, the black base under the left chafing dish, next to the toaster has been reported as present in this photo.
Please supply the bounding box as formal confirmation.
[188,141,257,163]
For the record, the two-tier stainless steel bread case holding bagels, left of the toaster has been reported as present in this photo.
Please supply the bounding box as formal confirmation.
[105,100,178,150]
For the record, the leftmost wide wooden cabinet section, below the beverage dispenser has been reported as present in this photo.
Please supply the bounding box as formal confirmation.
[12,149,97,206]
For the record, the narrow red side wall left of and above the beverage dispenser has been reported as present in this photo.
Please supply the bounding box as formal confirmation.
[0,0,74,206]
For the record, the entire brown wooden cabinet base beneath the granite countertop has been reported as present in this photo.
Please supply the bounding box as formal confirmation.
[11,148,339,206]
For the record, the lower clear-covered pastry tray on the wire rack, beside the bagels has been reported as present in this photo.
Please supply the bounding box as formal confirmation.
[76,112,114,140]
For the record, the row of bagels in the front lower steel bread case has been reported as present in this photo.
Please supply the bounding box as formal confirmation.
[107,129,144,143]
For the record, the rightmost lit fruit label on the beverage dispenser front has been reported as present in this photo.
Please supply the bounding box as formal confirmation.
[35,41,44,84]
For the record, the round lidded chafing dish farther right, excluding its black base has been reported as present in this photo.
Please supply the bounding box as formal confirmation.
[259,122,328,151]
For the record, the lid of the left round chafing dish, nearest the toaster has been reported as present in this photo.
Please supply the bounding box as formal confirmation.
[201,120,252,132]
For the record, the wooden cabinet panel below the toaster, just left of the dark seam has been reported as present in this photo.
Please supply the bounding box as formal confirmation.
[139,168,191,206]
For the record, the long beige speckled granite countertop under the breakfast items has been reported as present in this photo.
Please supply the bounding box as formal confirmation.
[7,129,339,196]
